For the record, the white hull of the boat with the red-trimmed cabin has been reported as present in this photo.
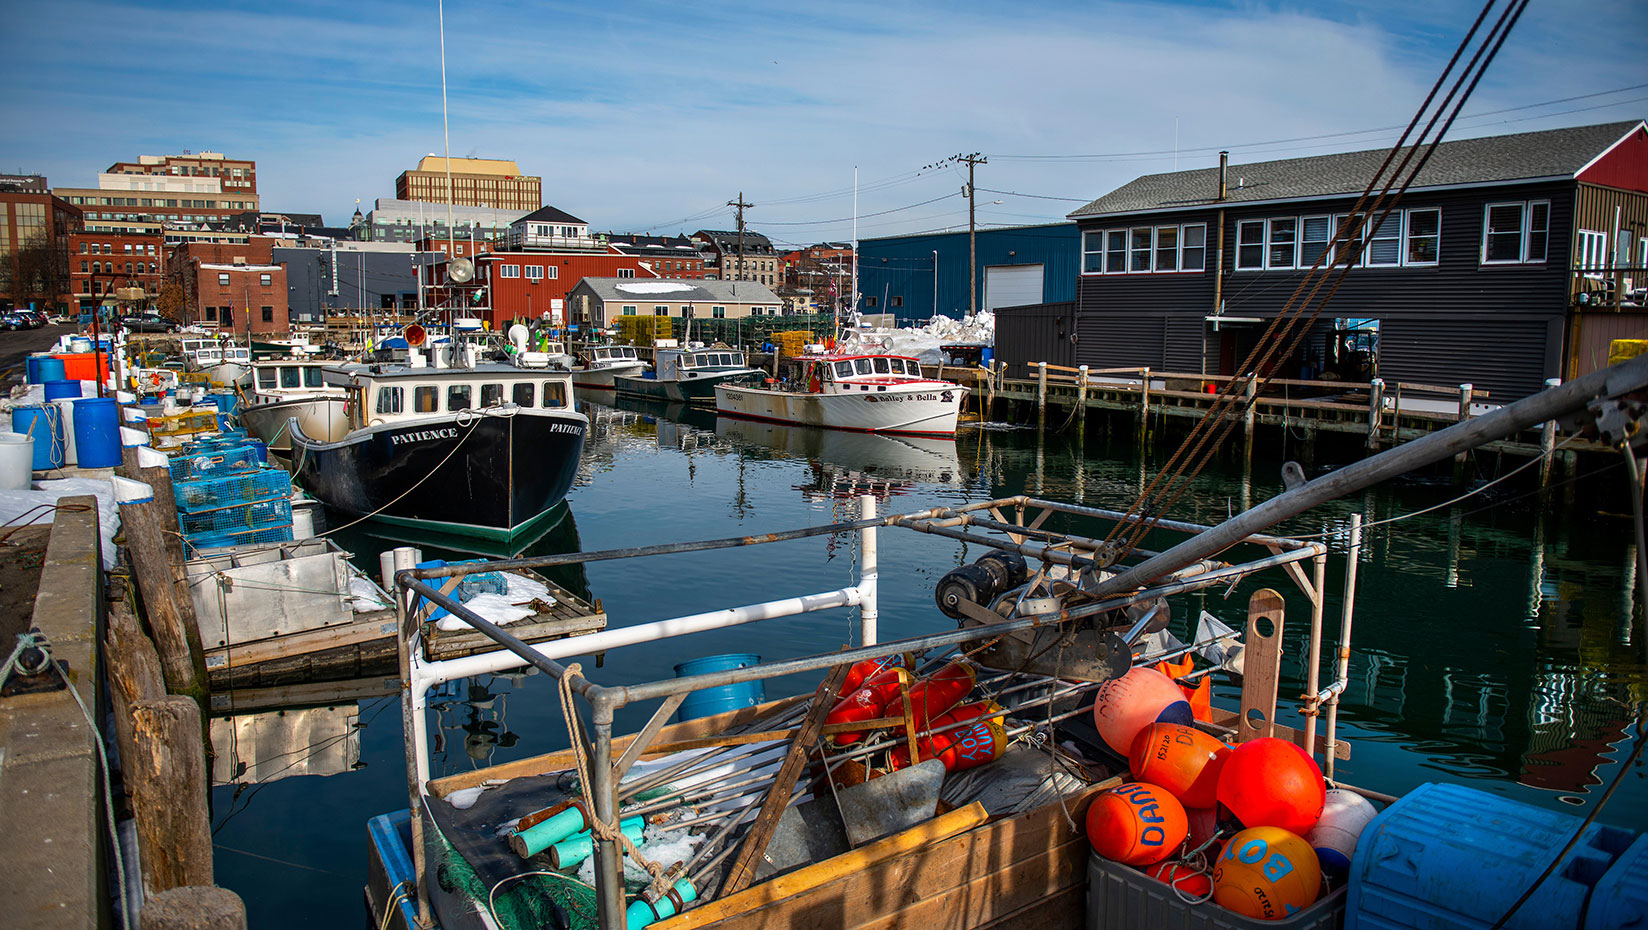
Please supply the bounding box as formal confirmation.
[715,383,967,437]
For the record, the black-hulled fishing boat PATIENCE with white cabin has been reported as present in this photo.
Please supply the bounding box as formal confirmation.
[287,343,588,538]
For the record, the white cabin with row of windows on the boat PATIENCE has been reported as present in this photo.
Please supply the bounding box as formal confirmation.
[325,364,572,430]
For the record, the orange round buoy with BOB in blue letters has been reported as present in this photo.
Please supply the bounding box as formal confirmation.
[1213,826,1322,920]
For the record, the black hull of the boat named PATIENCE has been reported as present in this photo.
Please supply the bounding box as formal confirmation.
[287,409,588,539]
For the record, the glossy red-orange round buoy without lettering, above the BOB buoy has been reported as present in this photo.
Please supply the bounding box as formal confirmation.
[1218,737,1327,836]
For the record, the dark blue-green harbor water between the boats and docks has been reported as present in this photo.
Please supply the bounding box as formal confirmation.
[213,394,1648,927]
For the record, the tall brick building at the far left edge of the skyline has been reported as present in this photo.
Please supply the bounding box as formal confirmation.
[0,191,81,307]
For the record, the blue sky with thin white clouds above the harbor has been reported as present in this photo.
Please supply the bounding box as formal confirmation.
[0,0,1648,244]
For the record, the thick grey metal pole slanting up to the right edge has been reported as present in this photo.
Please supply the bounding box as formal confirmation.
[1091,356,1648,597]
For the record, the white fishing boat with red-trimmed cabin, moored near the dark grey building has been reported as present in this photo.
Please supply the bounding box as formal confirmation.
[715,353,967,437]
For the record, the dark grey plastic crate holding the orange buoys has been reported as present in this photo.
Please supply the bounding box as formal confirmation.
[1088,854,1345,930]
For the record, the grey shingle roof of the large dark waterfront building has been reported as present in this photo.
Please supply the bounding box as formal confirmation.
[1070,120,1641,219]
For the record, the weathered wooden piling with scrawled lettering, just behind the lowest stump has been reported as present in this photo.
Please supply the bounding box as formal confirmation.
[131,694,213,890]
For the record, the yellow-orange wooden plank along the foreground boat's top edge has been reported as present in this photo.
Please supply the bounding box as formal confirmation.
[653,801,989,930]
